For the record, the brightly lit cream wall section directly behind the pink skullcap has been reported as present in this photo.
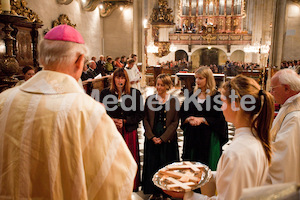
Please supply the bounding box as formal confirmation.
[26,0,103,59]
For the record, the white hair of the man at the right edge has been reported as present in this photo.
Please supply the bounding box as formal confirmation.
[275,69,300,92]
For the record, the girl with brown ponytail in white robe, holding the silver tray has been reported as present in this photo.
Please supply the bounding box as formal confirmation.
[167,75,274,200]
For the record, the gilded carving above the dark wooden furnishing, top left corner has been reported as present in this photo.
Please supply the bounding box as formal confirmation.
[10,0,43,23]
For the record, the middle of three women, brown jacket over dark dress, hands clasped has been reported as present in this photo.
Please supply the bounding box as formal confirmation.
[143,74,180,199]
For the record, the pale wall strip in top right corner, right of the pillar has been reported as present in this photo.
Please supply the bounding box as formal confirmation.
[282,2,300,61]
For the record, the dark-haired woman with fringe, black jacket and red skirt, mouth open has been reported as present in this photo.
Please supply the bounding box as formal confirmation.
[100,68,144,191]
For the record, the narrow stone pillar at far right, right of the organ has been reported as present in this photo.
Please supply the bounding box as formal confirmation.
[269,0,286,68]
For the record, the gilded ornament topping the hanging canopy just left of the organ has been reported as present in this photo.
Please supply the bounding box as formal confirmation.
[149,0,174,25]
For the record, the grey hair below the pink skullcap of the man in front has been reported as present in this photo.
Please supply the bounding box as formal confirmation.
[39,39,88,66]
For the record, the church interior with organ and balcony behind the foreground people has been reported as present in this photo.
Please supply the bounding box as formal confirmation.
[0,0,300,200]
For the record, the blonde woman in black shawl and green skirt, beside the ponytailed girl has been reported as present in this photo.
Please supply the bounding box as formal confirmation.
[180,67,228,170]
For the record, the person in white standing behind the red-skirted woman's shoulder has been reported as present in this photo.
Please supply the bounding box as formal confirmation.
[125,58,141,90]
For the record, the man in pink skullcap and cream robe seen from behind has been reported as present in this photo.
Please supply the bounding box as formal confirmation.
[0,25,137,200]
